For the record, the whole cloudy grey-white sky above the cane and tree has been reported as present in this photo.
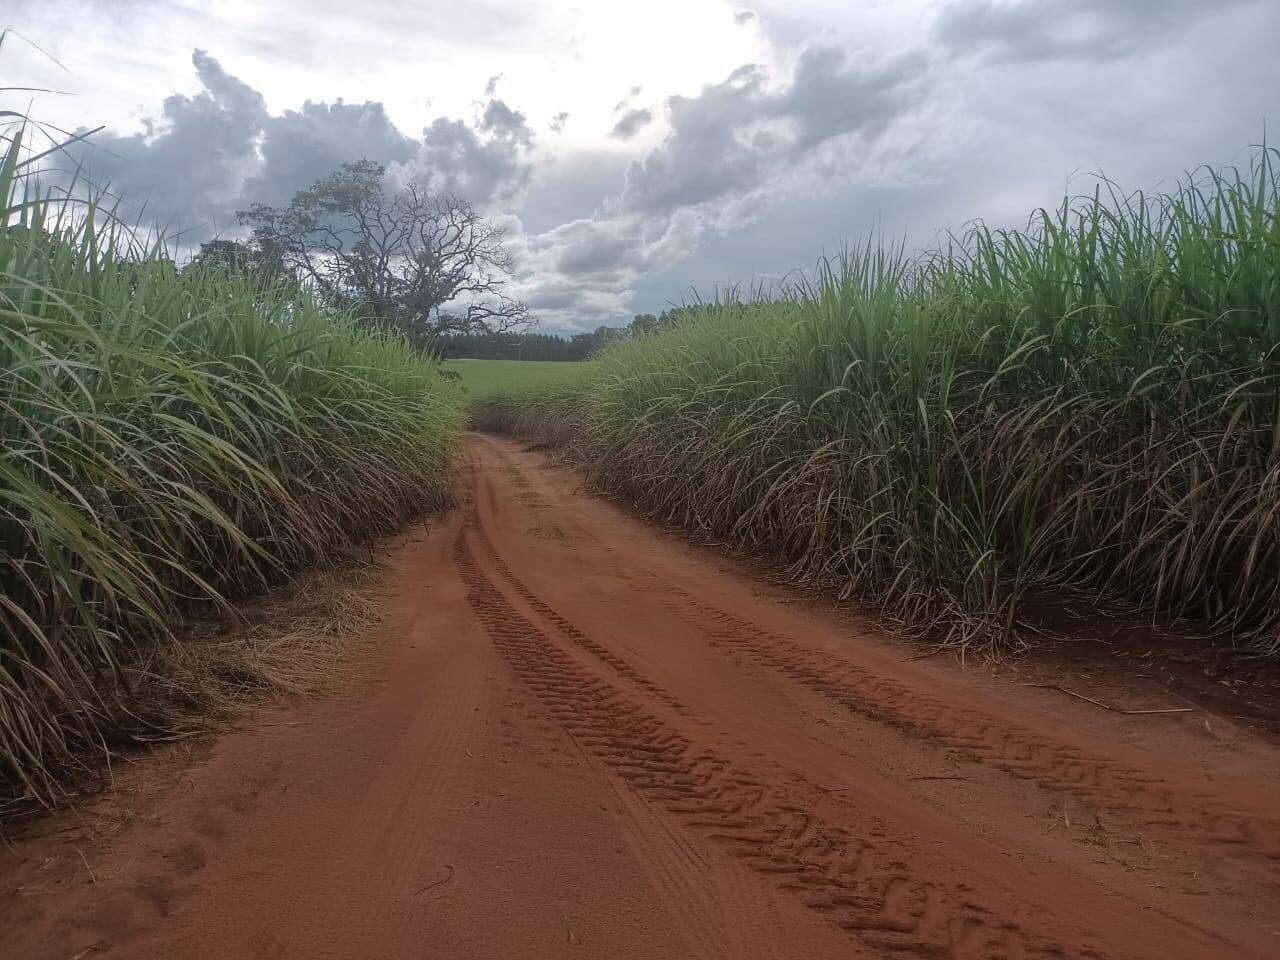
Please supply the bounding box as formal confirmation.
[10,0,1280,332]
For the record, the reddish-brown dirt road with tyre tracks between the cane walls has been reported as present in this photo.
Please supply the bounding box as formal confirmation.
[10,438,1280,960]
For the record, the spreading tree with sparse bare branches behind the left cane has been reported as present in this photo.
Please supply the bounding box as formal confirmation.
[237,160,535,335]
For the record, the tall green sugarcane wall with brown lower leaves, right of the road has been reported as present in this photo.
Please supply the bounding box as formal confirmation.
[477,150,1280,657]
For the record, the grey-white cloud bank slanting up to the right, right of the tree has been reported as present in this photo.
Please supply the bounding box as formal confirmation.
[509,46,924,328]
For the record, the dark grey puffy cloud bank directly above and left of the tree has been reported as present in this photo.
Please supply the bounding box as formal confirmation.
[52,50,534,243]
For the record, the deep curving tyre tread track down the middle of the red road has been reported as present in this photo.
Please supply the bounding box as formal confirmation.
[454,504,1198,960]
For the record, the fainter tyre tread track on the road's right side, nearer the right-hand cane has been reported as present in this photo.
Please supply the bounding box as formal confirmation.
[473,444,1280,873]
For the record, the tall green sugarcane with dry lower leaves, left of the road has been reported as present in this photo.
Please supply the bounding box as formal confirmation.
[0,128,463,803]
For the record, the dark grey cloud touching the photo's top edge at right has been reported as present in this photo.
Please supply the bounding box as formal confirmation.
[934,0,1257,61]
